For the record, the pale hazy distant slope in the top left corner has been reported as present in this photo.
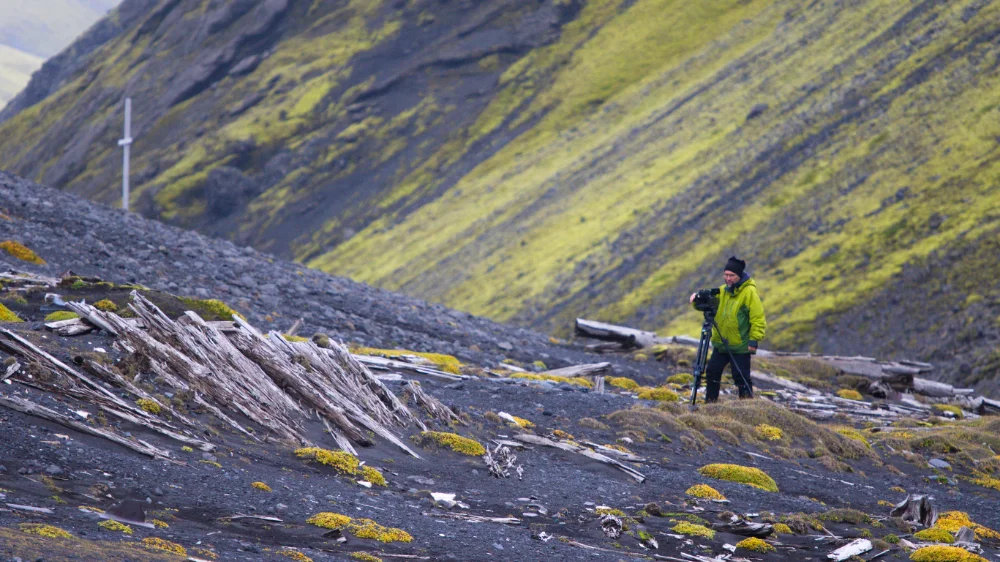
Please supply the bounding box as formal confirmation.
[0,0,120,108]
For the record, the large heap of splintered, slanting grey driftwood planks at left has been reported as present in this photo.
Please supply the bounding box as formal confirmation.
[0,291,460,457]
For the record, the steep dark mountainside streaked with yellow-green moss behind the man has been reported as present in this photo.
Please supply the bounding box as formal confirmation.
[0,0,1000,382]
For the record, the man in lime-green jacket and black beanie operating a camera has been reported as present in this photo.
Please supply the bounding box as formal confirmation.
[705,257,767,402]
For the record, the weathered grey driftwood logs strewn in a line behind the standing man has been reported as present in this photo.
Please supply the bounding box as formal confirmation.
[574,318,1000,415]
